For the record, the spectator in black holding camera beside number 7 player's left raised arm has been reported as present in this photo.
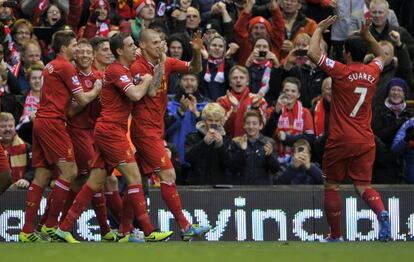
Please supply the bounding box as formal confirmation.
[284,33,328,108]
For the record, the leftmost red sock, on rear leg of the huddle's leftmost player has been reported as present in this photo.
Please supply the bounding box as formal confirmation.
[22,183,43,233]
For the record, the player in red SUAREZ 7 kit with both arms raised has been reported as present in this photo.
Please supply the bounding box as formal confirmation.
[308,16,390,242]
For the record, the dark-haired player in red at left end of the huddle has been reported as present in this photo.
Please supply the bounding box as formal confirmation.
[19,30,102,242]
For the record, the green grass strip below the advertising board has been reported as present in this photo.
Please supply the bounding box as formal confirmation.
[0,241,414,262]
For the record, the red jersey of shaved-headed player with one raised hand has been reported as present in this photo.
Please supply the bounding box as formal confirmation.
[131,56,190,136]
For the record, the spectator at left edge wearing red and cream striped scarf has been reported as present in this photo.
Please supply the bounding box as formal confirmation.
[0,112,34,188]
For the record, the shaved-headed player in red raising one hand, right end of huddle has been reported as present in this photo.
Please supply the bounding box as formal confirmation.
[131,29,210,241]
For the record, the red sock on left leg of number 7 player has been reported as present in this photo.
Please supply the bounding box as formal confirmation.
[325,189,342,238]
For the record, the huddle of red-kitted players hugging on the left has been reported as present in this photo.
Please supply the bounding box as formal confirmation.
[12,29,210,243]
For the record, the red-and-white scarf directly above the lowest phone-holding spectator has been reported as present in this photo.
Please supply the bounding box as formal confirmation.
[276,101,304,162]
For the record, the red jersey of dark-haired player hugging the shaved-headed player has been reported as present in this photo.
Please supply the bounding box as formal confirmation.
[97,61,134,130]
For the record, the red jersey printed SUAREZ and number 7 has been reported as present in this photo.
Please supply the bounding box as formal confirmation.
[318,55,383,144]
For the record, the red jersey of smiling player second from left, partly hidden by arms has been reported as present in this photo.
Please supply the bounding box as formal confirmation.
[68,70,102,129]
